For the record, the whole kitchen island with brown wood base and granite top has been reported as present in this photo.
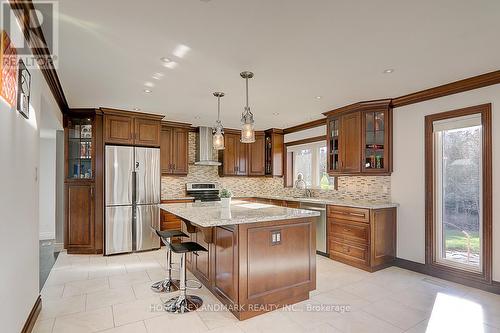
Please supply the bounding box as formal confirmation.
[160,200,319,320]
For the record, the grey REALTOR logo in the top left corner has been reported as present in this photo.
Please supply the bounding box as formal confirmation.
[0,0,59,68]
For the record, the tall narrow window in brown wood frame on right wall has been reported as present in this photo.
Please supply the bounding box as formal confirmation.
[426,105,491,280]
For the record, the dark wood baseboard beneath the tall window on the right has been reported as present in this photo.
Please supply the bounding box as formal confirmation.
[394,258,500,295]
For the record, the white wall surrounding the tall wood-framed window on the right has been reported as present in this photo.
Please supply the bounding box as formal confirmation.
[392,85,500,281]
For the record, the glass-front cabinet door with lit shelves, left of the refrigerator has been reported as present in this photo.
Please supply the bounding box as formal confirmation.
[66,118,94,179]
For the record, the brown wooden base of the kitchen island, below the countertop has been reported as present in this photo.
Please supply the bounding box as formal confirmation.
[177,217,316,320]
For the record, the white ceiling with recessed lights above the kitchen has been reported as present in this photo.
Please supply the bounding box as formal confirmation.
[45,0,500,129]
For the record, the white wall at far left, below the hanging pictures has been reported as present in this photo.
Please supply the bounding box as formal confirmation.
[0,35,62,332]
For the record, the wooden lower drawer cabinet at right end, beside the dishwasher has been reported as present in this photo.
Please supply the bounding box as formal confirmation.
[328,206,396,272]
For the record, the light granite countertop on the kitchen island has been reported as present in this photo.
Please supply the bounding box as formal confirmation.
[160,199,320,227]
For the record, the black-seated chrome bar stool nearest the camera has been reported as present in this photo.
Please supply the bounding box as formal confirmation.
[163,242,207,313]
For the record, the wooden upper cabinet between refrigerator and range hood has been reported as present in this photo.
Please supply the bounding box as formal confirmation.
[160,125,189,176]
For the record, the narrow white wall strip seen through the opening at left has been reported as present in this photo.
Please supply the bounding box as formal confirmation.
[38,135,56,239]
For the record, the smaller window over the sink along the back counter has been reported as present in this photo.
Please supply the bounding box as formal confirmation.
[287,141,329,188]
